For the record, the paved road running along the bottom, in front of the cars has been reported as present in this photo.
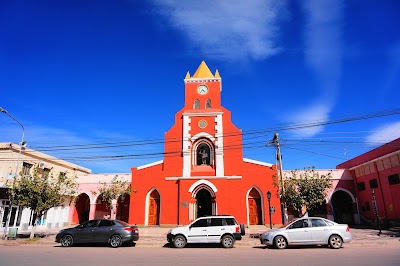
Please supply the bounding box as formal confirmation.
[0,241,400,266]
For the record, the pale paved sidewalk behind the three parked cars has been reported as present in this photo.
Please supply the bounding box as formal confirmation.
[0,226,400,247]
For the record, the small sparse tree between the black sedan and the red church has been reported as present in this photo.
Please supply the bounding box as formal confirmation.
[92,175,136,216]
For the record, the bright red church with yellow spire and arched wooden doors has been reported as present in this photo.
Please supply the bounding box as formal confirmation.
[128,61,282,226]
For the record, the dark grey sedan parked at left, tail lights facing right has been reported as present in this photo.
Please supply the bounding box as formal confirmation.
[56,219,139,248]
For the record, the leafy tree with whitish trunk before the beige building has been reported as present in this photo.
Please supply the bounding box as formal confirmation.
[12,167,77,239]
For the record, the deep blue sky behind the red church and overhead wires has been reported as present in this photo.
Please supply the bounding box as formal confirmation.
[0,0,400,173]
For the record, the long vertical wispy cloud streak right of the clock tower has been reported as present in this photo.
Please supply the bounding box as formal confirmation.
[289,0,343,136]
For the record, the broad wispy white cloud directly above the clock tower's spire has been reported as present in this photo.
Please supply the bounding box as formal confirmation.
[150,0,284,60]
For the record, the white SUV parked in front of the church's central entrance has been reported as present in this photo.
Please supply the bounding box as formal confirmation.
[167,215,245,248]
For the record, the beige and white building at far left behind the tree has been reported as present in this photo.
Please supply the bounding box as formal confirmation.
[0,142,91,230]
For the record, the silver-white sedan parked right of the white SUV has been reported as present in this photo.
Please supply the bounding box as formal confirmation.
[260,217,352,249]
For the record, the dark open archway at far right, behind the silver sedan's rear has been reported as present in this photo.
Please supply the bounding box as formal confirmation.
[331,190,354,224]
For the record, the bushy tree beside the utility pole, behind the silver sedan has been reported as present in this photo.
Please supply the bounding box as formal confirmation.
[275,167,332,215]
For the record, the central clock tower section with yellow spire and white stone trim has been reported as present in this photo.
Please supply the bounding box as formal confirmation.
[182,61,224,177]
